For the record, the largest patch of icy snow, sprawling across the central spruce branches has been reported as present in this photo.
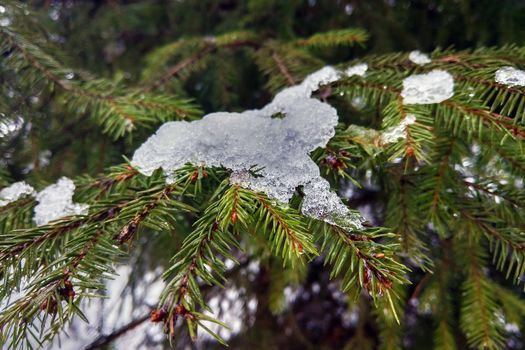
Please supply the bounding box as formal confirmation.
[132,67,362,230]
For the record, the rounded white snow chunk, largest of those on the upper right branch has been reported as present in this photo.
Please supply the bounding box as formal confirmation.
[401,69,454,104]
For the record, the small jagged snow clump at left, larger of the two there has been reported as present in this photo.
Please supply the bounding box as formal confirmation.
[33,177,89,226]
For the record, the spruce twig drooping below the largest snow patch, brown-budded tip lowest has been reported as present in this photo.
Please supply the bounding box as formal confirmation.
[159,182,246,343]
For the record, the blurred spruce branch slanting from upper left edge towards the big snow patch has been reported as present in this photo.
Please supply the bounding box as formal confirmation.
[0,27,200,138]
